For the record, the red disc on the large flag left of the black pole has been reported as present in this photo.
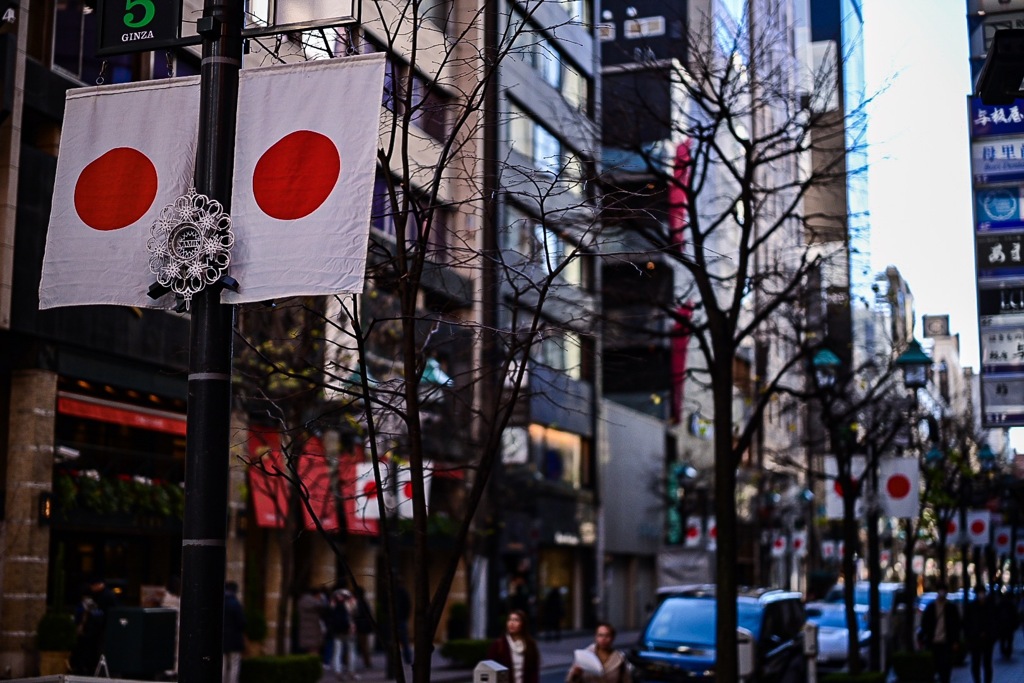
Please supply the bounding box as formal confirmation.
[75,147,157,230]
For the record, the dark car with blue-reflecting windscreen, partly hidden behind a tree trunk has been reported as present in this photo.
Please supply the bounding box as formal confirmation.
[629,585,807,683]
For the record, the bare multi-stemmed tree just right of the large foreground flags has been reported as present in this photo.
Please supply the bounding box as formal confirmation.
[232,0,597,682]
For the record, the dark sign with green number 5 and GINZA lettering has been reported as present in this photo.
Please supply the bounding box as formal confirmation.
[96,0,186,56]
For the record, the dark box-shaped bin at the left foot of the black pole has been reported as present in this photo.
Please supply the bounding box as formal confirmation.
[103,607,178,679]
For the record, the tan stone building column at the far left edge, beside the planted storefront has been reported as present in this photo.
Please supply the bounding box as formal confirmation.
[0,370,57,678]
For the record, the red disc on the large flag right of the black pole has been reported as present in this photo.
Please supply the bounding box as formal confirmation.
[253,130,341,220]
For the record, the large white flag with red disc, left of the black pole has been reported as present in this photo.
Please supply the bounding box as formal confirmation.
[39,76,200,308]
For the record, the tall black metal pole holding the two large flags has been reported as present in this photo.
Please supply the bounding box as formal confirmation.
[178,0,243,683]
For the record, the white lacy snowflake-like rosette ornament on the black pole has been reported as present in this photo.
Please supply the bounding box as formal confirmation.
[146,187,234,308]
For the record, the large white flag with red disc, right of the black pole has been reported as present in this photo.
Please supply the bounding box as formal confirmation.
[222,53,384,303]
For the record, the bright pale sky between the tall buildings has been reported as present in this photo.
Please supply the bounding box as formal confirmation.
[863,0,979,371]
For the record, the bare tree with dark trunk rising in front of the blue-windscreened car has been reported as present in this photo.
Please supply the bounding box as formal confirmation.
[604,3,861,681]
